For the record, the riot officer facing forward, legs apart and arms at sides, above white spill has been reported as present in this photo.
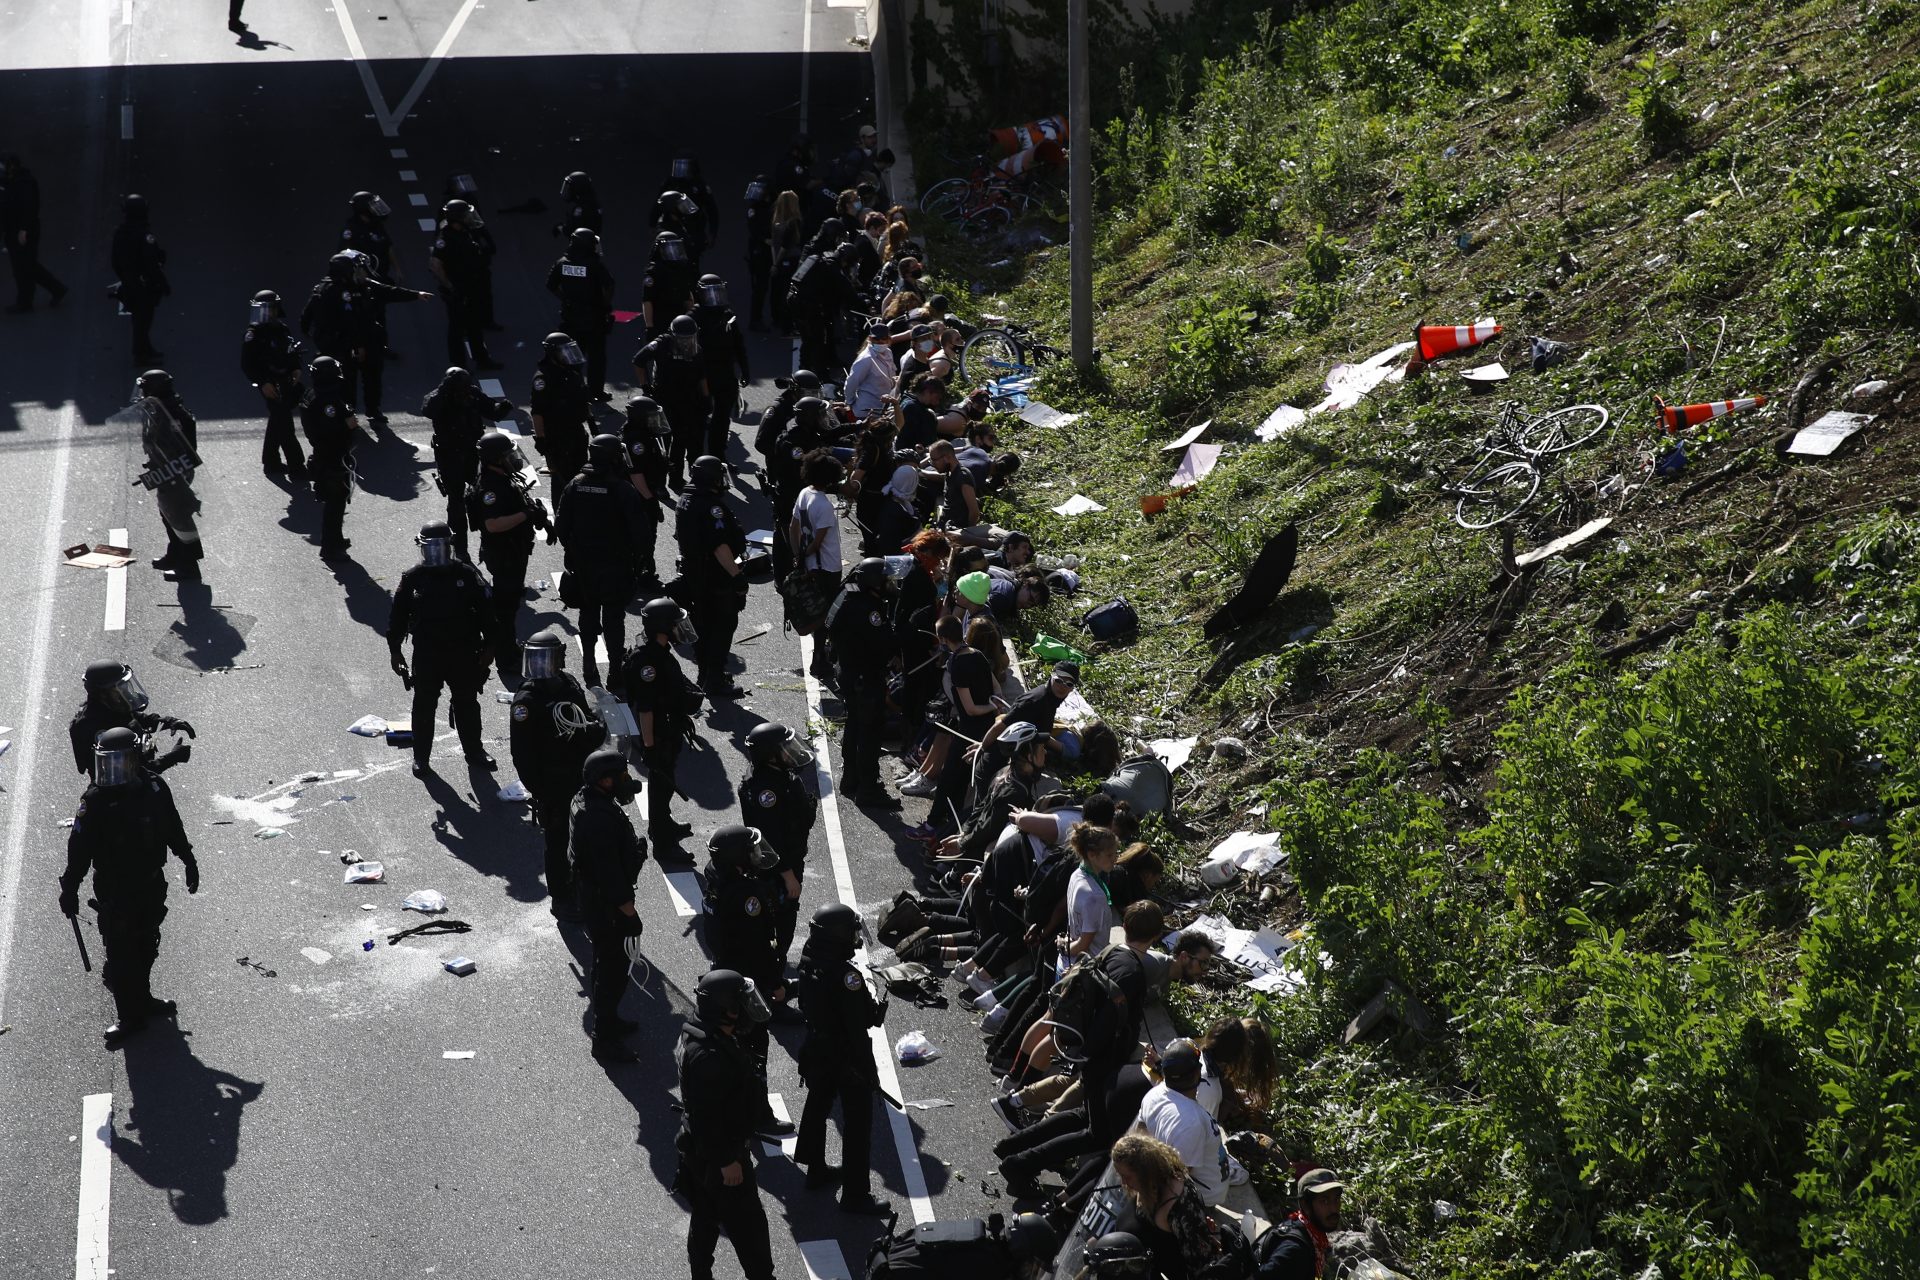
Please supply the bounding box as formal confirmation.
[386,522,493,777]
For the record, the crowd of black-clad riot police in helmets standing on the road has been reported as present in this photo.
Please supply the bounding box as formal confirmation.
[60,155,944,1280]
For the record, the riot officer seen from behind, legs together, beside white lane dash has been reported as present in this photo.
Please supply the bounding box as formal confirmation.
[555,436,653,691]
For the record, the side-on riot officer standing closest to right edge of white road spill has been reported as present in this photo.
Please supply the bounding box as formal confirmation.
[568,747,647,1063]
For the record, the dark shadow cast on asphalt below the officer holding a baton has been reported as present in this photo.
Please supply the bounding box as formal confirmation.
[113,1021,265,1226]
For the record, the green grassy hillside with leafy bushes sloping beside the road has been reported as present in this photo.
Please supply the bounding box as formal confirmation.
[914,0,1920,1280]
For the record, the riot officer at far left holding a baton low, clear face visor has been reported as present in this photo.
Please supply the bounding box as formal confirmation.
[60,729,200,1048]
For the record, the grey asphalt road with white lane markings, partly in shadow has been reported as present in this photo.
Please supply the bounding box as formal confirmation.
[0,0,1036,1280]
